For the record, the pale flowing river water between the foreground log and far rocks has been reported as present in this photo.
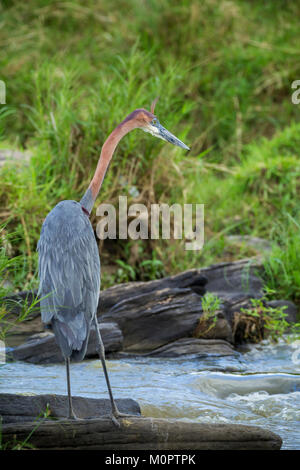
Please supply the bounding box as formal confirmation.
[0,340,300,449]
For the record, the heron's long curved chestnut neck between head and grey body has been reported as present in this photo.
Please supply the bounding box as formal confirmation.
[80,117,138,212]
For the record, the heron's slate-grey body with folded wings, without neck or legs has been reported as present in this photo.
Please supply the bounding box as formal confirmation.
[38,201,100,356]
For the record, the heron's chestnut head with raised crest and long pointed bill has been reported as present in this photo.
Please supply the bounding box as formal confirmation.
[128,99,190,150]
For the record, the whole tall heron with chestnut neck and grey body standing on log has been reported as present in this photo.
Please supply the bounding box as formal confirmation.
[38,100,189,424]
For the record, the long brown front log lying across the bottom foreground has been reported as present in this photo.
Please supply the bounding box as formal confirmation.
[2,417,282,451]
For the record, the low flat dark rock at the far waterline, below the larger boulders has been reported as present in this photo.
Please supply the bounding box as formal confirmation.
[141,338,239,357]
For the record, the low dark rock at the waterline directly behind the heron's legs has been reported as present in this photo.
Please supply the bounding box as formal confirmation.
[12,323,123,364]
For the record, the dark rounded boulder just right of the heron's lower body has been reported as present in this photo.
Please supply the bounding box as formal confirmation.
[101,287,202,353]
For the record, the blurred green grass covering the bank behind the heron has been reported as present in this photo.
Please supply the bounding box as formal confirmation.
[0,0,300,316]
